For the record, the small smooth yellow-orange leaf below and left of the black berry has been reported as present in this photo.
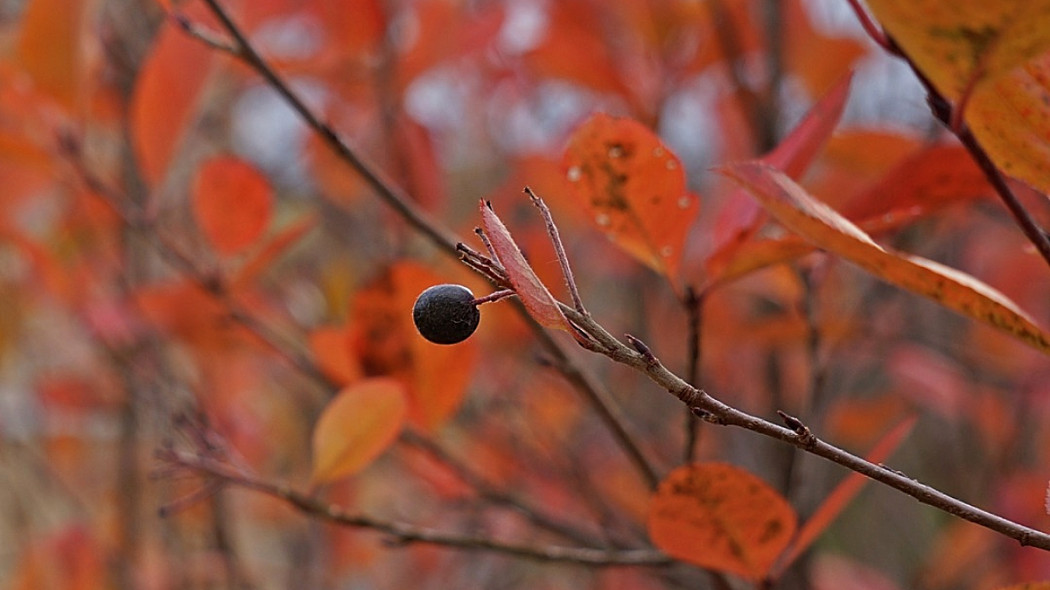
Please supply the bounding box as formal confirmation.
[311,378,406,484]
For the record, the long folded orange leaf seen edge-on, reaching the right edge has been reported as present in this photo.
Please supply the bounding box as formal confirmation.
[722,162,1050,353]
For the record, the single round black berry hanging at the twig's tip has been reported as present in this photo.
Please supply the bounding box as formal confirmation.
[412,285,481,344]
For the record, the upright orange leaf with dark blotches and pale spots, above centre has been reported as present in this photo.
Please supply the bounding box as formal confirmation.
[562,113,699,281]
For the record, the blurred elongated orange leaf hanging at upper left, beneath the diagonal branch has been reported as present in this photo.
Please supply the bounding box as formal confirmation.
[129,12,215,186]
